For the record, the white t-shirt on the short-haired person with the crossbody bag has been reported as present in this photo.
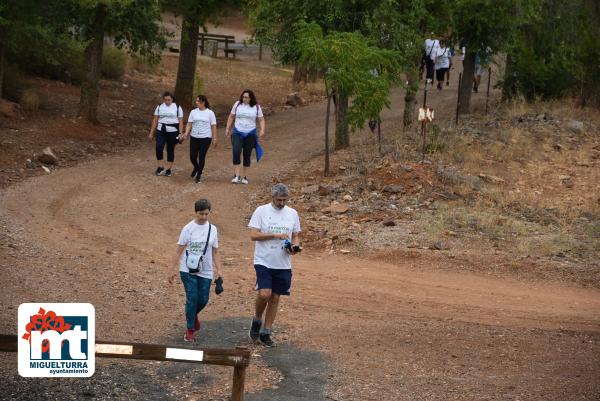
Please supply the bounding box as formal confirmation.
[177,220,219,280]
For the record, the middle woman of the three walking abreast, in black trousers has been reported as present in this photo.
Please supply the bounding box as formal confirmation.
[183,95,217,183]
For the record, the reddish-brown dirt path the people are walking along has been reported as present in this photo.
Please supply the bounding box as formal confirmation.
[0,79,600,401]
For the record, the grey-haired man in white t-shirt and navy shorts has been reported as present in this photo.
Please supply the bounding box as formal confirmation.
[248,184,301,347]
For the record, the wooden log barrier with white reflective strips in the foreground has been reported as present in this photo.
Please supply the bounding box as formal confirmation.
[0,334,250,401]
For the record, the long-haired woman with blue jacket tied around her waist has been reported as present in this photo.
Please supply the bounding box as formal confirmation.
[225,89,265,184]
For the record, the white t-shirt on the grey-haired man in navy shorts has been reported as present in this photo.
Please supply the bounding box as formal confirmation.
[248,203,300,269]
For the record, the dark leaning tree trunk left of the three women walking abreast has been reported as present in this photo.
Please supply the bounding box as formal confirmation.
[79,4,108,124]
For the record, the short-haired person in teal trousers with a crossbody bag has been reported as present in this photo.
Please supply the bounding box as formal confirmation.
[173,199,221,341]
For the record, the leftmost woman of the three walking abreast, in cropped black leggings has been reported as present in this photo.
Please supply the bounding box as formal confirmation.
[148,92,183,177]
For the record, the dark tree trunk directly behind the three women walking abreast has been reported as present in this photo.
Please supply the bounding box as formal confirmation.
[175,9,200,110]
